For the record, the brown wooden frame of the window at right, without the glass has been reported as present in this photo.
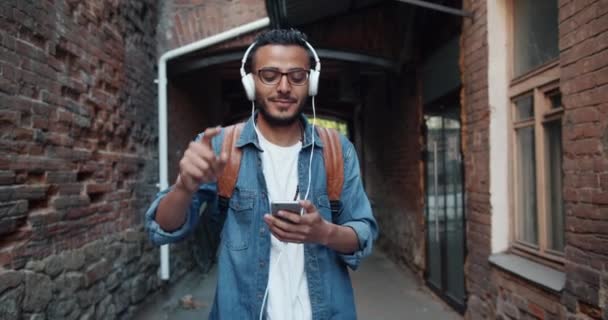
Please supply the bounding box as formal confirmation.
[507,0,565,270]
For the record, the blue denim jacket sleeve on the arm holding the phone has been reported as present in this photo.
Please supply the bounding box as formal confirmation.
[337,137,378,270]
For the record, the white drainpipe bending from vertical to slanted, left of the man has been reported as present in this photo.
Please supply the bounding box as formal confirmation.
[157,18,270,280]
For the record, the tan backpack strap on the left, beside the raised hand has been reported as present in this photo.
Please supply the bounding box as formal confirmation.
[217,123,244,199]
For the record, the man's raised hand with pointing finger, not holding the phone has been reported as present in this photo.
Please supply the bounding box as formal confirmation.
[175,127,228,194]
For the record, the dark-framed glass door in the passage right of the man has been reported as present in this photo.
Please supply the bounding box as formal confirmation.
[425,107,466,311]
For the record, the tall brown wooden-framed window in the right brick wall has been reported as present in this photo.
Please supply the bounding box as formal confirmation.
[509,0,564,262]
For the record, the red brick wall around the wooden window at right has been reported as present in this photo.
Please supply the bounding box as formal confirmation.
[462,0,608,319]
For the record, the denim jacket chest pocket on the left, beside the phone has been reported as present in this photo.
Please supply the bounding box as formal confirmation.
[223,197,254,250]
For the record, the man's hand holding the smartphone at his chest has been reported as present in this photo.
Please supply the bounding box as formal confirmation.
[264,200,334,245]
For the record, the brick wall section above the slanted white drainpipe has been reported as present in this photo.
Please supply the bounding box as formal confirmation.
[159,0,267,52]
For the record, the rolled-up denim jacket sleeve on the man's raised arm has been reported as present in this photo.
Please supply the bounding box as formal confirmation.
[144,133,223,245]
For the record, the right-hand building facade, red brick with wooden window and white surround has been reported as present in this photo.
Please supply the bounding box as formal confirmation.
[462,0,608,319]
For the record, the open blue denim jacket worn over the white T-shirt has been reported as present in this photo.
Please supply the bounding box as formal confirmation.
[145,116,378,320]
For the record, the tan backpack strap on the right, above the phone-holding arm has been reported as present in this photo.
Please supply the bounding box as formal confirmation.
[317,127,344,201]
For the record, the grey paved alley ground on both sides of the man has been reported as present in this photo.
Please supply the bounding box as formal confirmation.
[135,251,462,320]
